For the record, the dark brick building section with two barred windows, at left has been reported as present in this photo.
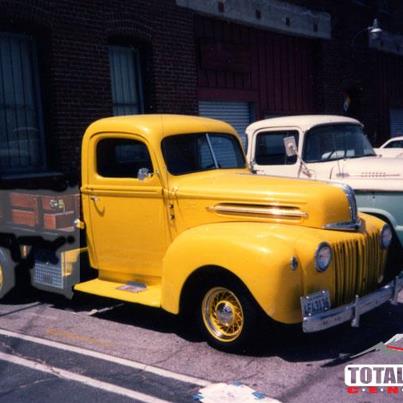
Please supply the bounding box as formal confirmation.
[0,0,197,178]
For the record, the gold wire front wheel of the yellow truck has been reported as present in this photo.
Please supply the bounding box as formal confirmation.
[201,287,245,342]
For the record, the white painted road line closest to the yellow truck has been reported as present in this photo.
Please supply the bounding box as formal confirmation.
[0,329,211,386]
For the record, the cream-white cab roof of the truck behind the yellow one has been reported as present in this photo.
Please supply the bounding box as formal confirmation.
[246,115,363,133]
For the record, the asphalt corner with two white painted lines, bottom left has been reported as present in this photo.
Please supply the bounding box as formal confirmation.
[0,329,204,403]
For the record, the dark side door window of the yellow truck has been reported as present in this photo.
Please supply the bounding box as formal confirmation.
[96,138,153,178]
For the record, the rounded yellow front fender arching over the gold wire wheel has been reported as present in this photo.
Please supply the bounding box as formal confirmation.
[161,222,302,323]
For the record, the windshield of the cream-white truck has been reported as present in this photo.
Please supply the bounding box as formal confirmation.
[302,124,376,162]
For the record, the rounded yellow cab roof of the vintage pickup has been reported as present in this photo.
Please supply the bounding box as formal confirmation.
[85,114,237,142]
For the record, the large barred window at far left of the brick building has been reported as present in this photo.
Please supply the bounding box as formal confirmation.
[0,33,46,174]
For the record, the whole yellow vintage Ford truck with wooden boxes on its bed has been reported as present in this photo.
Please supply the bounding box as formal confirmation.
[0,115,403,350]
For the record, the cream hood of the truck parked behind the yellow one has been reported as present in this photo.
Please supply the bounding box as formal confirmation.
[330,156,403,191]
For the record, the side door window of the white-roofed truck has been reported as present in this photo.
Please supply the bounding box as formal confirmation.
[255,130,299,165]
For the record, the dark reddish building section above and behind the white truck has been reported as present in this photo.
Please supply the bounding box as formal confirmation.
[188,0,403,144]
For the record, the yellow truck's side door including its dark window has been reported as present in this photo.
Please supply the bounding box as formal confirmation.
[83,134,169,280]
